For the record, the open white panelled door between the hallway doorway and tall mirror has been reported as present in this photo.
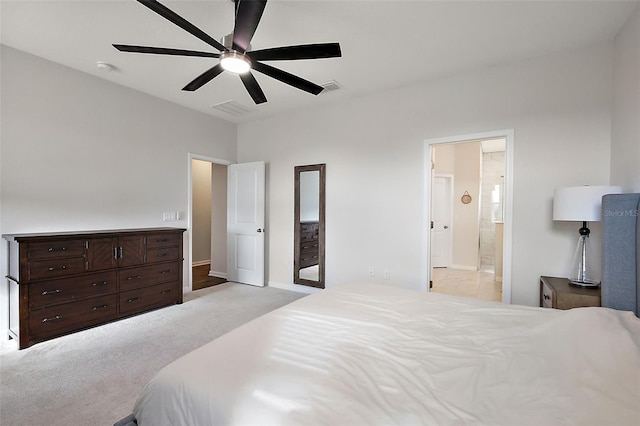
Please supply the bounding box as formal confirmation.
[227,161,265,287]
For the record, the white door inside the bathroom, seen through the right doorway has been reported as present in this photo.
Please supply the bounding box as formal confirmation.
[431,176,451,268]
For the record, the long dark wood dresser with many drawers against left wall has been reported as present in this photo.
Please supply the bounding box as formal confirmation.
[3,228,185,349]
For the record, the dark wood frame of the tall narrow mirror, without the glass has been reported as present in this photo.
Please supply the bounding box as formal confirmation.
[293,164,326,288]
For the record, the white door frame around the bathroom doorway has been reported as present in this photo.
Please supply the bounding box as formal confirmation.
[422,129,514,304]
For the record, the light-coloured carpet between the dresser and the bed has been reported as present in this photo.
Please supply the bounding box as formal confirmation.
[0,283,304,426]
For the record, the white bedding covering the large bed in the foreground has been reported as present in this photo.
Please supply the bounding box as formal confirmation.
[134,283,640,426]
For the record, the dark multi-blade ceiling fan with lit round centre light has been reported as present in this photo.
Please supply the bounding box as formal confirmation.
[113,0,342,104]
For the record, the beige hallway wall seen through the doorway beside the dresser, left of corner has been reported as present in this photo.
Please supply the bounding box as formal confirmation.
[191,159,212,265]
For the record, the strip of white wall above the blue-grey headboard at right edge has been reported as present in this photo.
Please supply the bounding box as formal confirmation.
[611,6,640,192]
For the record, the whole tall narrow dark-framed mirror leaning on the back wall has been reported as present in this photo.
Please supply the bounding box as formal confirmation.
[293,164,325,288]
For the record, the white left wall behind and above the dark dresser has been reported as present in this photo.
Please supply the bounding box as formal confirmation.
[0,46,236,336]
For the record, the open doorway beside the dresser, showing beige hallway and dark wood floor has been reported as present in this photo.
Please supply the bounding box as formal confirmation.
[188,155,230,290]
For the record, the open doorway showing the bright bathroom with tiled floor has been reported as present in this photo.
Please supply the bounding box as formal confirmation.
[425,131,513,303]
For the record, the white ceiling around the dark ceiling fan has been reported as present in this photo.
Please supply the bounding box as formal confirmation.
[0,0,639,122]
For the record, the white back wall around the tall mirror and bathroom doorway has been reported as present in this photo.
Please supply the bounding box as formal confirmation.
[238,44,613,305]
